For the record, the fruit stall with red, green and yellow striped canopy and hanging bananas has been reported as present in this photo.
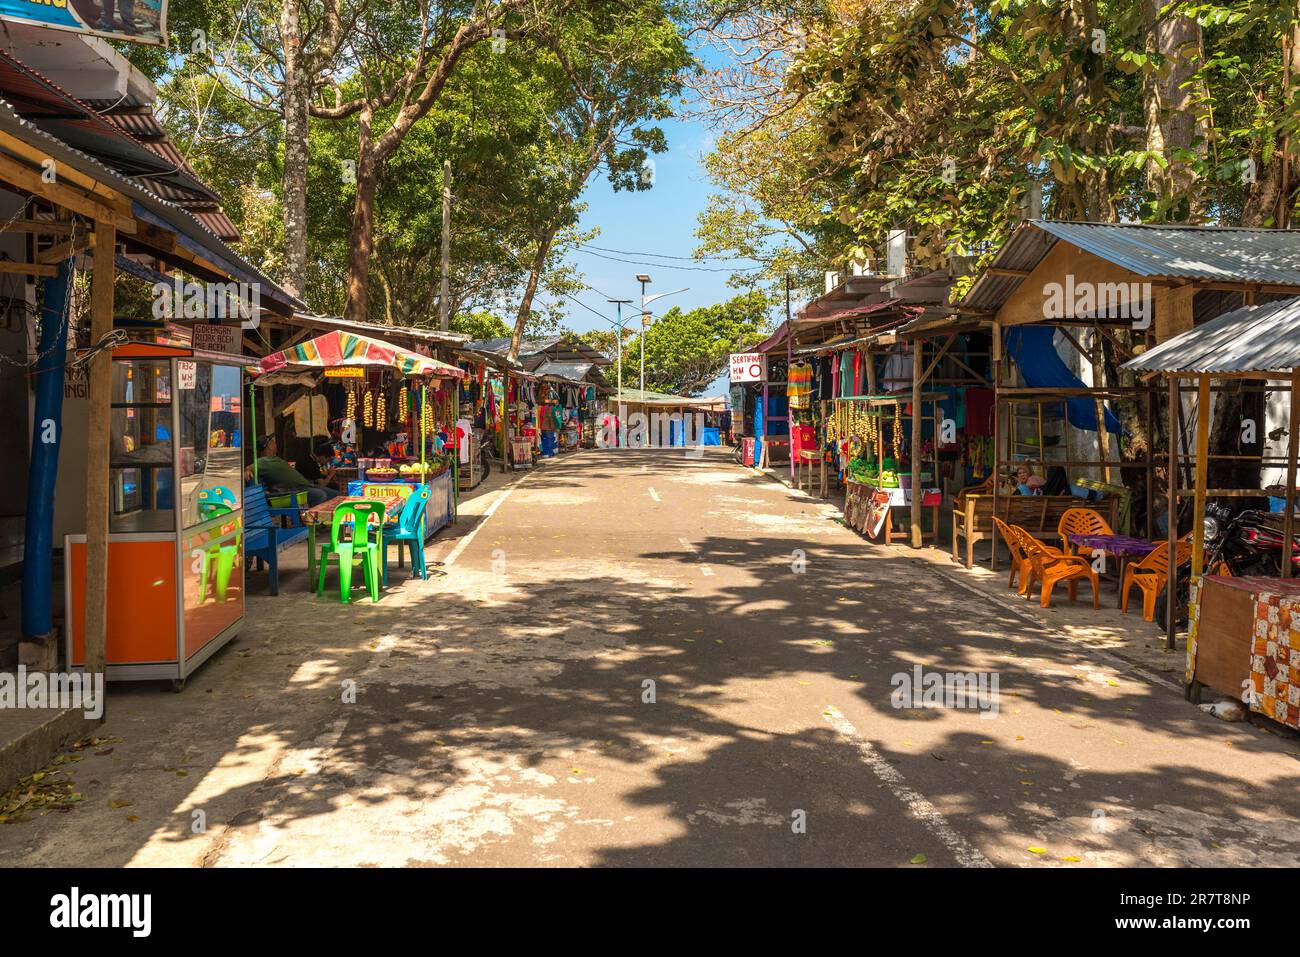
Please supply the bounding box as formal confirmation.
[251,332,465,536]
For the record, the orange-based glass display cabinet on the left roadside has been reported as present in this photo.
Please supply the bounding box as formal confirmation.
[64,343,246,689]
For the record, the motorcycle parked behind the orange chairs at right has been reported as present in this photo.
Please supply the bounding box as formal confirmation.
[1156,502,1300,625]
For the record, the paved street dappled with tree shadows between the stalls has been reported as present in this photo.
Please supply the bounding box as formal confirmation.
[0,450,1300,867]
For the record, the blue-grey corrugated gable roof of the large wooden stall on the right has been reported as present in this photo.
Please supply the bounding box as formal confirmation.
[962,220,1300,311]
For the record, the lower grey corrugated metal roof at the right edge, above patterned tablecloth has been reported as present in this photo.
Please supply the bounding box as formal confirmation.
[1122,298,1300,374]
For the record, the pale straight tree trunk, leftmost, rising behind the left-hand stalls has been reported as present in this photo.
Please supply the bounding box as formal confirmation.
[280,0,312,296]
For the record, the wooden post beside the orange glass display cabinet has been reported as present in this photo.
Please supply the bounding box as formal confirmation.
[85,220,117,675]
